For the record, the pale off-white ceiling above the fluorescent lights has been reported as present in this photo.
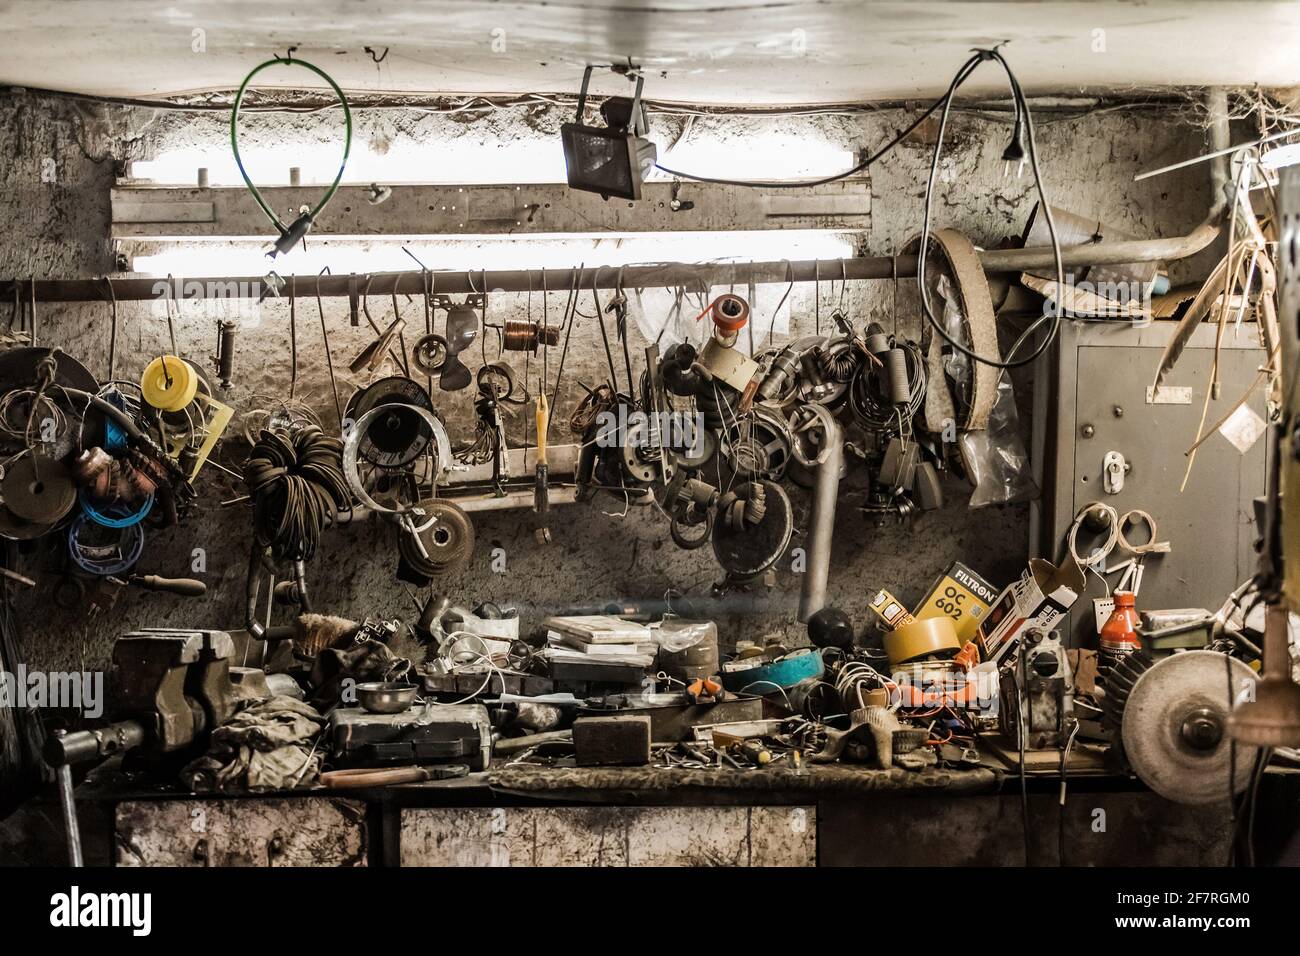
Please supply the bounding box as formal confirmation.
[0,0,1300,104]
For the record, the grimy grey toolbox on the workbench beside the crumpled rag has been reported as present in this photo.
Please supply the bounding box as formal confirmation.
[330,702,491,770]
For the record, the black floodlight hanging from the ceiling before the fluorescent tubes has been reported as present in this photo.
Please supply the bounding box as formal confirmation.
[560,66,658,199]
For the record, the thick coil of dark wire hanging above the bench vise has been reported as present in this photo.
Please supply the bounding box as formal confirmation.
[244,425,351,561]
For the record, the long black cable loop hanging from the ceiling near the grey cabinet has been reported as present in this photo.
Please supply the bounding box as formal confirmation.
[917,49,1065,369]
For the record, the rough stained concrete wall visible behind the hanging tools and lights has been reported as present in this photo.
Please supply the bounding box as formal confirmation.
[0,87,1206,667]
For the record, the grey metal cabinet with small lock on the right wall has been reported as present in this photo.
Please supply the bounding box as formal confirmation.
[1030,321,1268,646]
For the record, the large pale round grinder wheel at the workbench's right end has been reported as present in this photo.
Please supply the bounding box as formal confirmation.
[1122,650,1258,804]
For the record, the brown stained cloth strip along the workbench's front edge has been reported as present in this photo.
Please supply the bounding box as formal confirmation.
[488,763,998,795]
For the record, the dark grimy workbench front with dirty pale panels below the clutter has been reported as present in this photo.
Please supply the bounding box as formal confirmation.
[45,763,1230,866]
